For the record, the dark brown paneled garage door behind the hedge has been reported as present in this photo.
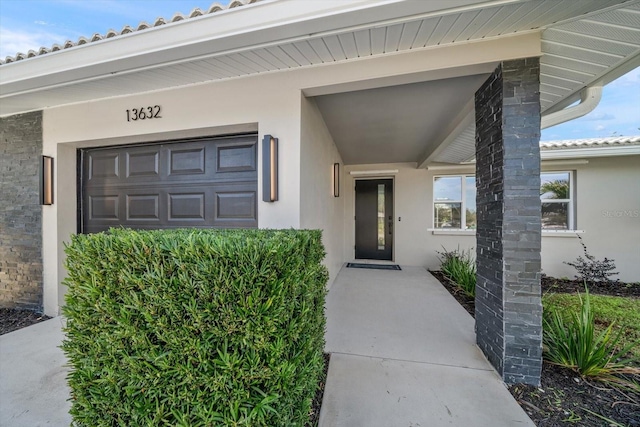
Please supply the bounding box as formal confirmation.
[80,135,258,233]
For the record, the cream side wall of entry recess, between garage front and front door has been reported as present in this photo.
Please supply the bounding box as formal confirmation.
[300,97,344,286]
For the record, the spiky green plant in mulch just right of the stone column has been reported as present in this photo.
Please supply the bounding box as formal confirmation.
[543,289,640,386]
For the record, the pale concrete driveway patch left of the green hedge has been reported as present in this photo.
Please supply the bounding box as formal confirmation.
[0,317,71,427]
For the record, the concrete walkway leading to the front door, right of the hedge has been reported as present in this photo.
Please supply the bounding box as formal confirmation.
[320,267,534,427]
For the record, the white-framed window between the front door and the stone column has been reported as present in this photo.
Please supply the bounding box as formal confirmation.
[433,175,476,230]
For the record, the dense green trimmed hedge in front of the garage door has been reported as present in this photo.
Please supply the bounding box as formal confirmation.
[62,229,328,427]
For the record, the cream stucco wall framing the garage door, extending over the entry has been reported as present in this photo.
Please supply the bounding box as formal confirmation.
[37,33,540,315]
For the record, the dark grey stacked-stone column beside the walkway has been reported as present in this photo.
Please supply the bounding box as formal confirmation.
[475,58,542,385]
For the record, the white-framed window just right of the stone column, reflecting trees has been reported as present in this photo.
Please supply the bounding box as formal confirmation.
[540,172,574,230]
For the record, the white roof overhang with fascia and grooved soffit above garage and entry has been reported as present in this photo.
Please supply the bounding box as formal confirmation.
[0,0,640,116]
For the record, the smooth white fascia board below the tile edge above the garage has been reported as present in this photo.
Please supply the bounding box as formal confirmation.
[0,0,510,96]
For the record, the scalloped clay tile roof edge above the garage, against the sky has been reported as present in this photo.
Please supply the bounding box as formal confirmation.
[0,0,260,65]
